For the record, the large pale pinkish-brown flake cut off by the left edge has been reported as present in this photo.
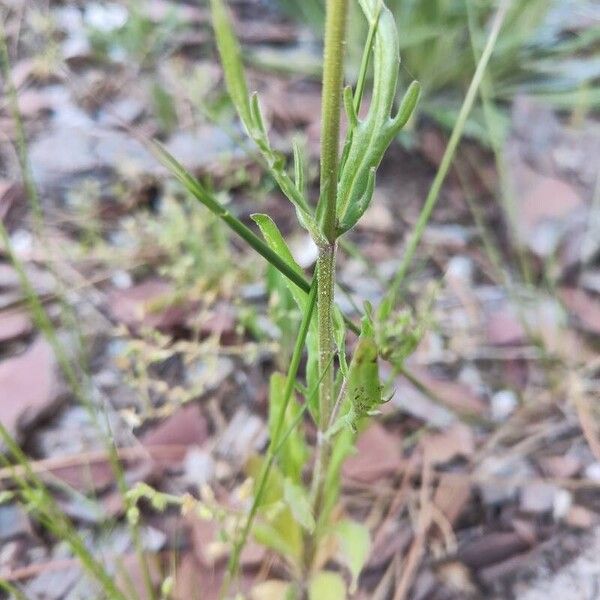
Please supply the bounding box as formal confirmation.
[0,337,64,437]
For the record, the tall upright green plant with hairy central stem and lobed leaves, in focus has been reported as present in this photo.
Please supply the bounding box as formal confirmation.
[155,0,419,600]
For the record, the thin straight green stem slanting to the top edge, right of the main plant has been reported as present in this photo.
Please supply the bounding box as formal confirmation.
[388,0,510,305]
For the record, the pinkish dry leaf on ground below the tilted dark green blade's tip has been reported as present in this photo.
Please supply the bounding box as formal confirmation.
[108,279,192,331]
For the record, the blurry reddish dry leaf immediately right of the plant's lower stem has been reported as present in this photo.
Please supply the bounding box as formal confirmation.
[342,423,405,483]
